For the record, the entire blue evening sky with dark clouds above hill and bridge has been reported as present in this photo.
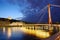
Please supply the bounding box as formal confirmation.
[0,0,60,23]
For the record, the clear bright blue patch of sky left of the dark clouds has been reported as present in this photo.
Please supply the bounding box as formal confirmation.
[0,0,23,18]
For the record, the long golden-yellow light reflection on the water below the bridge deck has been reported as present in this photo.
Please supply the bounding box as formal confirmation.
[21,27,50,38]
